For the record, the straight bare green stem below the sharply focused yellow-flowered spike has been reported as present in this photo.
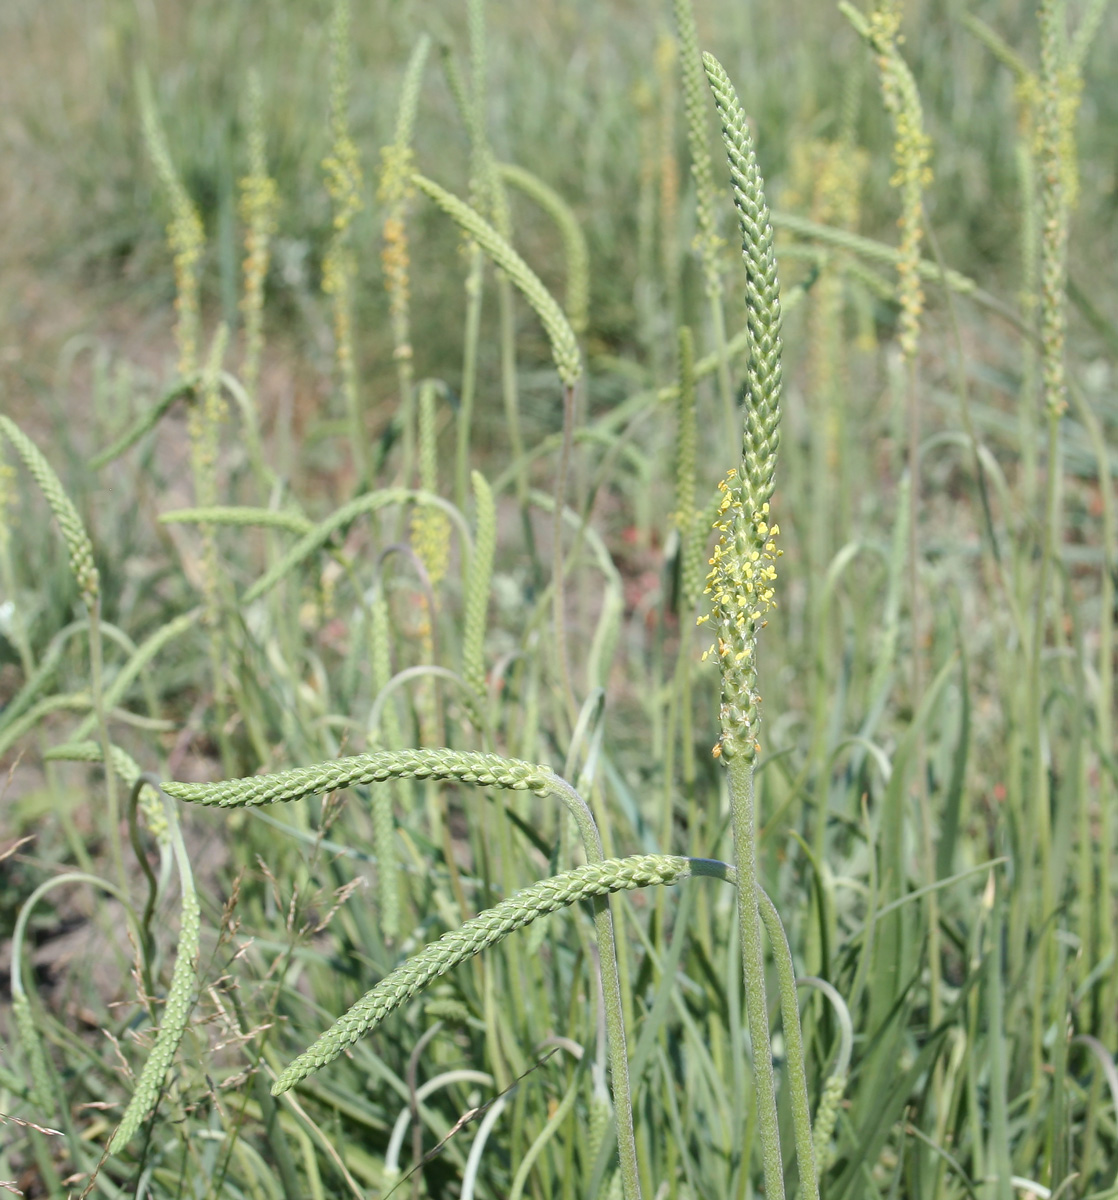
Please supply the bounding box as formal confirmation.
[729,754,785,1200]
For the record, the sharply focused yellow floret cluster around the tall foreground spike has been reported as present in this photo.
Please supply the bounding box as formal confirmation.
[698,470,782,664]
